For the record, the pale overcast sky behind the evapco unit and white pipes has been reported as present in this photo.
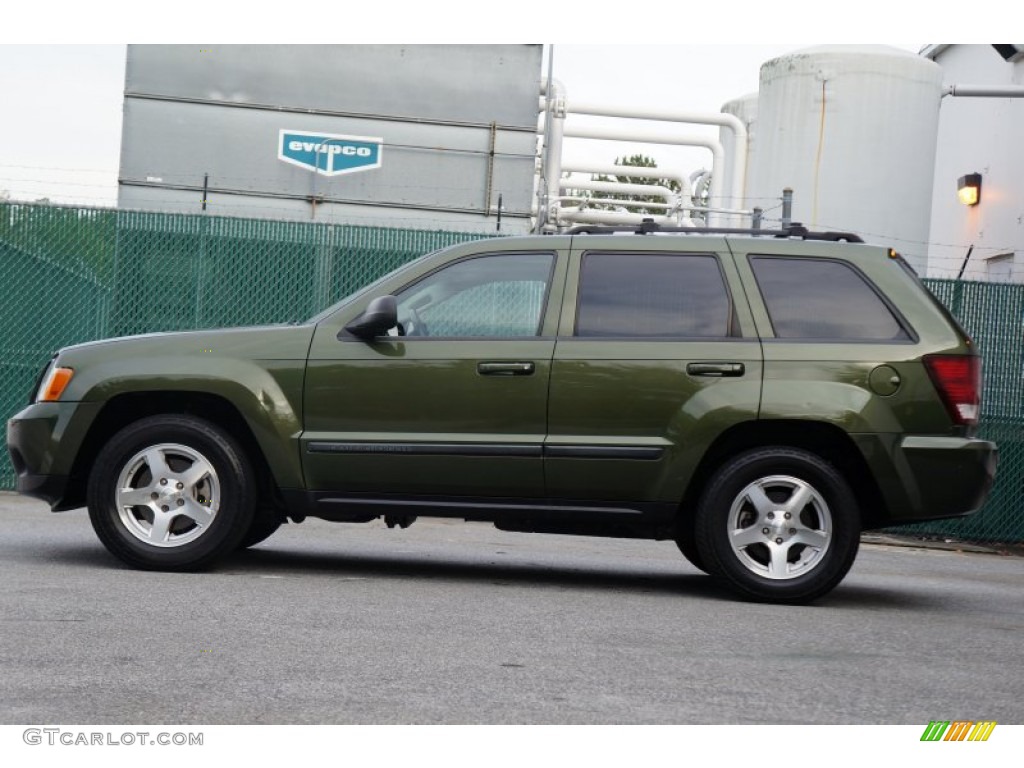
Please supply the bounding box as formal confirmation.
[0,44,920,205]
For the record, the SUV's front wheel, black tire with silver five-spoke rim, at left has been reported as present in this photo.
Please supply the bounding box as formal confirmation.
[87,415,256,570]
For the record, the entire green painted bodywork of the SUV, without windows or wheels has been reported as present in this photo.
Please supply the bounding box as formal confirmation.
[8,236,996,535]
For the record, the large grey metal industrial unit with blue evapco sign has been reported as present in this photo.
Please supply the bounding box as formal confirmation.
[118,45,542,233]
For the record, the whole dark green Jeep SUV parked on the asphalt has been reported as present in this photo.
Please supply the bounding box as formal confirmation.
[7,224,996,603]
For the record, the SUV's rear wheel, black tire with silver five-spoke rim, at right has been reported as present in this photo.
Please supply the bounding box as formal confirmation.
[695,446,860,603]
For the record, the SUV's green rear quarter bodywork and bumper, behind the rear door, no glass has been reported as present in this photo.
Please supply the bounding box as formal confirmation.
[729,241,996,524]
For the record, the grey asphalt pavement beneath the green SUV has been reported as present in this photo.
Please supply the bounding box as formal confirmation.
[0,494,1024,724]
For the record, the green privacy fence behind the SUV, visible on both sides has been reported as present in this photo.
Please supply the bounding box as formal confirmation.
[0,203,1024,542]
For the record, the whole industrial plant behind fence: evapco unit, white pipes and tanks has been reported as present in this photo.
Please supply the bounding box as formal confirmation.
[119,44,1024,282]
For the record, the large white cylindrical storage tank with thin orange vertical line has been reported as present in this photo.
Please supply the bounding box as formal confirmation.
[746,46,942,274]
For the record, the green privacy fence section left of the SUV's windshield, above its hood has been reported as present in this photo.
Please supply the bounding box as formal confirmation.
[0,203,495,488]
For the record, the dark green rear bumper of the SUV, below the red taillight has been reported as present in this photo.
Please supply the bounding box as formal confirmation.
[869,435,998,525]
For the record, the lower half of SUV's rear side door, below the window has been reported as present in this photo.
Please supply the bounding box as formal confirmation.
[546,350,761,503]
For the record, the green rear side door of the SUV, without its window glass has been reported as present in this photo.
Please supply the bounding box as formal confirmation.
[545,236,762,504]
